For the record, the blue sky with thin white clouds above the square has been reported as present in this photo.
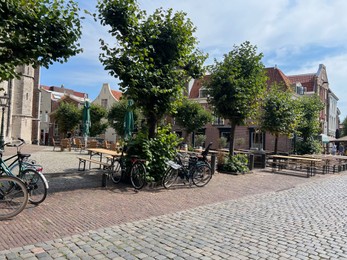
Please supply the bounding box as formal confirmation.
[41,0,347,119]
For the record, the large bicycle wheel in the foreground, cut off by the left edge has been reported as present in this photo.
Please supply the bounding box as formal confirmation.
[0,176,28,220]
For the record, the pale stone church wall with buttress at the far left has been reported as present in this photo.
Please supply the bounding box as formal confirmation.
[0,65,40,143]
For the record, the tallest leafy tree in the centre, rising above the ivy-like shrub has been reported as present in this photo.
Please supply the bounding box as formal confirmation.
[98,0,206,138]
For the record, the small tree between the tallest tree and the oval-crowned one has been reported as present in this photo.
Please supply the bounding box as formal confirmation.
[175,99,212,142]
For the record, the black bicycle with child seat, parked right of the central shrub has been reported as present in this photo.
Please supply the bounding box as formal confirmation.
[162,143,212,189]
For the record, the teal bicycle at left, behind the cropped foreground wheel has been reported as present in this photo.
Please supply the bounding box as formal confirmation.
[0,138,49,205]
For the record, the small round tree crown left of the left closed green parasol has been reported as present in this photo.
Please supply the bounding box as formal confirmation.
[54,102,82,135]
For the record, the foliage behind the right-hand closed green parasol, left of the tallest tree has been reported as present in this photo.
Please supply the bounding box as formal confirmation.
[107,99,141,137]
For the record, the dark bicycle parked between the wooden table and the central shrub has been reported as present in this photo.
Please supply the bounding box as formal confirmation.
[111,148,146,190]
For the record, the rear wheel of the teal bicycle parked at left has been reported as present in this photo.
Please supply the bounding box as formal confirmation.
[20,169,47,205]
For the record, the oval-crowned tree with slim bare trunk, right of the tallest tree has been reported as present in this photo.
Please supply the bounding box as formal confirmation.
[206,42,267,156]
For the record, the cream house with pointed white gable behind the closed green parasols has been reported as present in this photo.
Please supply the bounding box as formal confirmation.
[92,83,122,143]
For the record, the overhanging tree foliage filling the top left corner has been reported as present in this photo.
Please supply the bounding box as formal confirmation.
[0,0,82,82]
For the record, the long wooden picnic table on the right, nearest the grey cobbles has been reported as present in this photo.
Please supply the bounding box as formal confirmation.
[271,155,322,177]
